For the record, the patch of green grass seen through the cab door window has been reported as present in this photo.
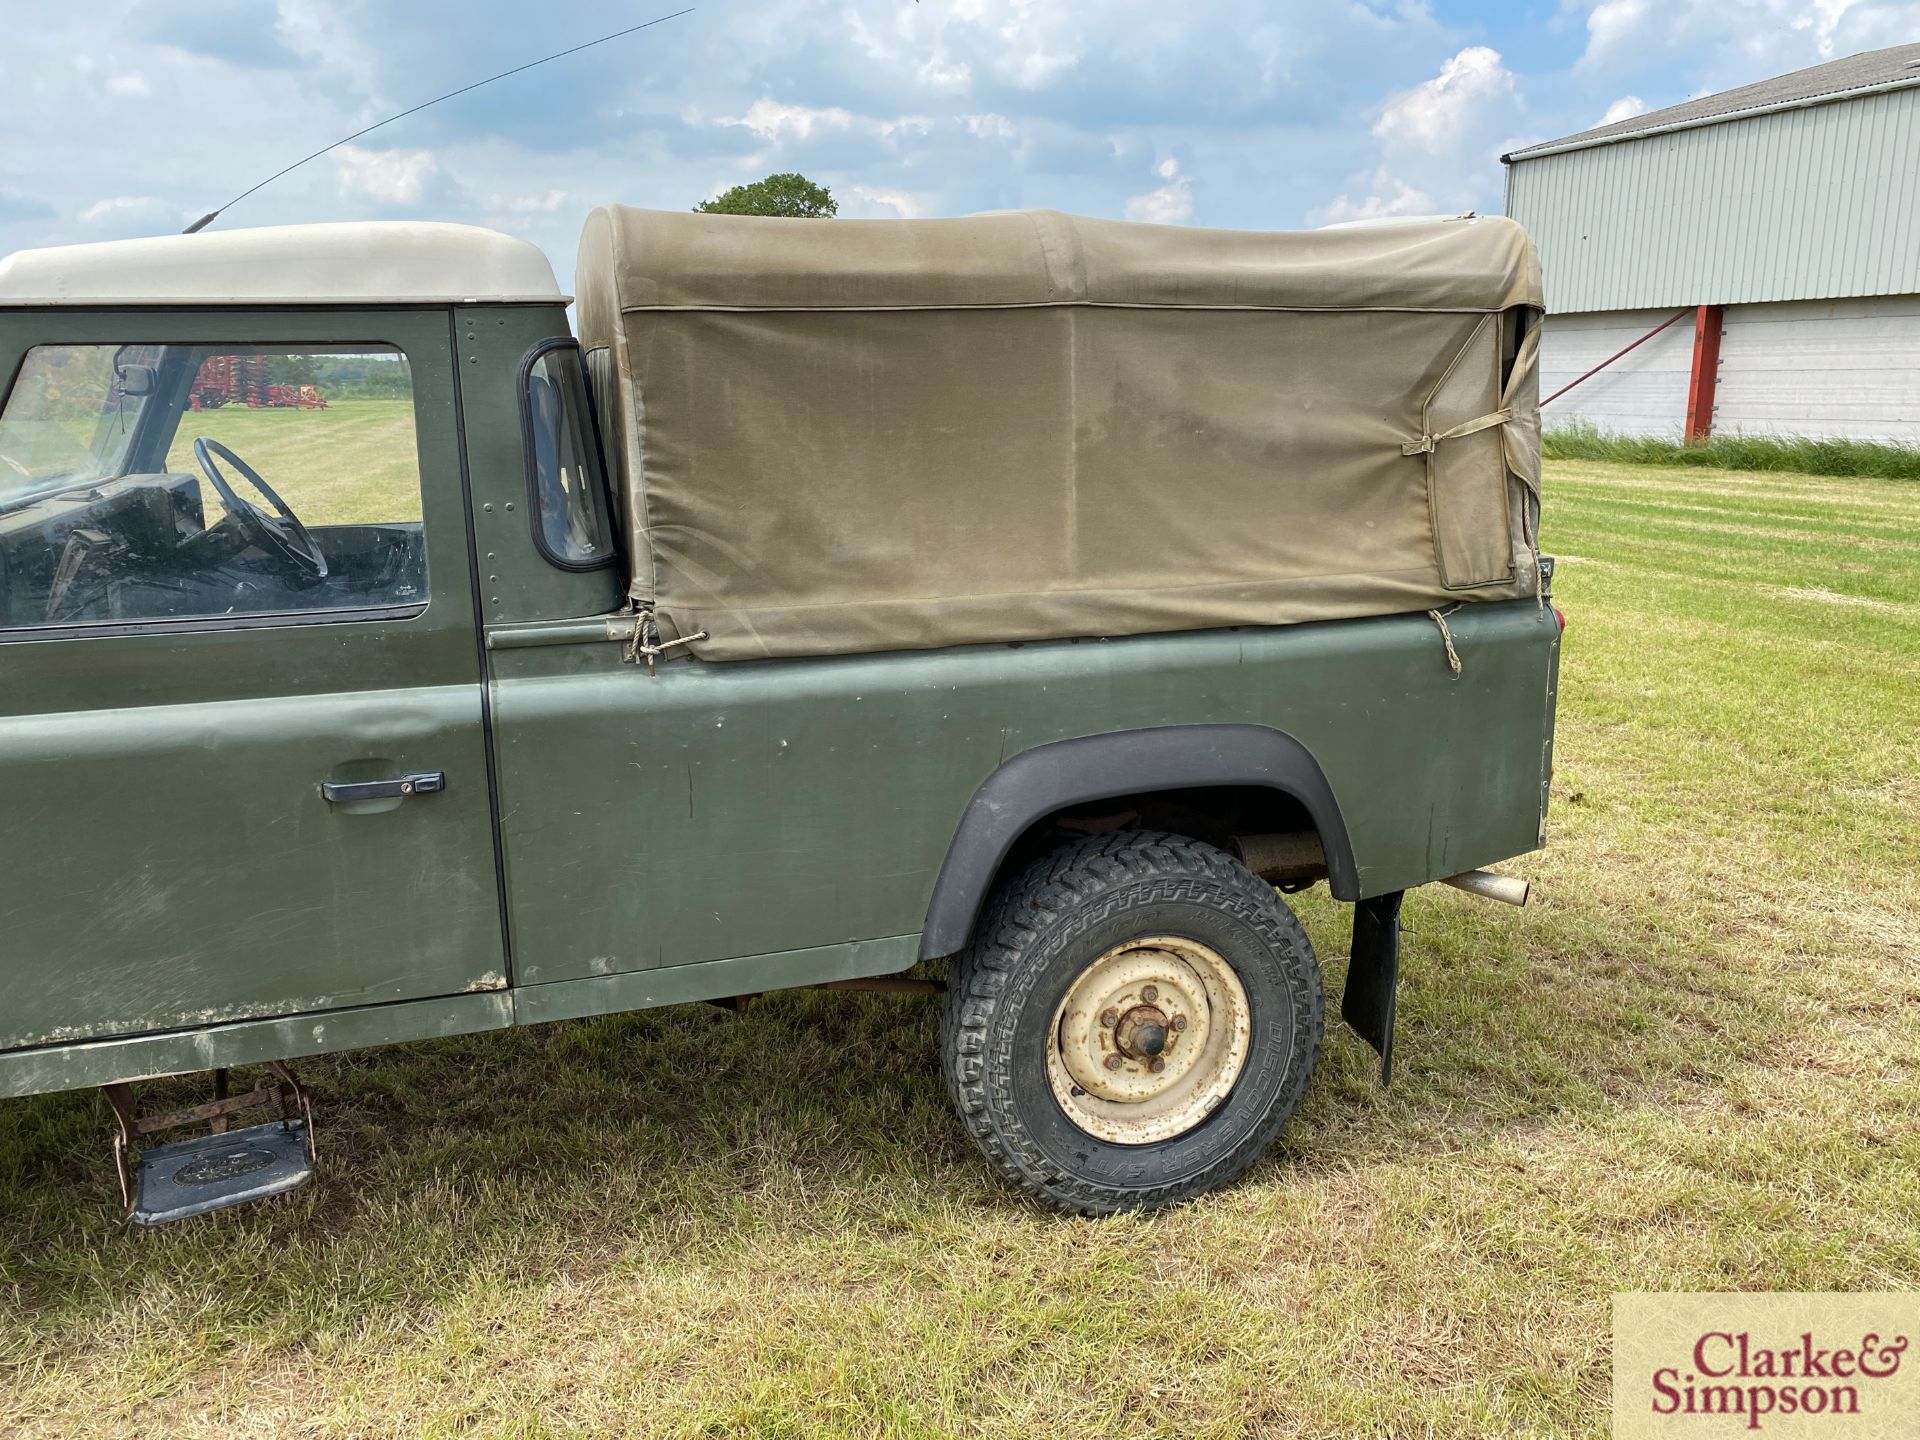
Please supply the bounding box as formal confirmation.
[167,399,420,524]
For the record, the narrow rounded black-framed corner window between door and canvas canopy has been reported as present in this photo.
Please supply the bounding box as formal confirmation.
[524,340,614,570]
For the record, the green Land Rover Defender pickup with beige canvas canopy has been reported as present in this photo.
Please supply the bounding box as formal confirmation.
[0,207,1561,1223]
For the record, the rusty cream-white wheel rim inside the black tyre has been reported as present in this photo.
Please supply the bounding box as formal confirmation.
[1046,935,1254,1144]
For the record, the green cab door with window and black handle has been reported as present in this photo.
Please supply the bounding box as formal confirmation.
[0,307,507,1048]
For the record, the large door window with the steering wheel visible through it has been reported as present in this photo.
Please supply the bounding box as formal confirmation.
[0,344,426,628]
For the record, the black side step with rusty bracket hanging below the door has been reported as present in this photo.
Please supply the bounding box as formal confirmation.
[102,1060,315,1225]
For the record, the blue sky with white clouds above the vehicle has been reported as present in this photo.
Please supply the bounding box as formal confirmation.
[0,0,1920,293]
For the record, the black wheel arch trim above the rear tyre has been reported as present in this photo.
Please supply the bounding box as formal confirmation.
[920,724,1359,960]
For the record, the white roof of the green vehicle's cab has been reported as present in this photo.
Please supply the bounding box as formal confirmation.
[0,221,566,309]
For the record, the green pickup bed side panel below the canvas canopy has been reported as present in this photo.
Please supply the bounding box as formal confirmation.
[492,601,1559,985]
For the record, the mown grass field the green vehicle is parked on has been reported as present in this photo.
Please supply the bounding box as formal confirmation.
[0,458,1920,1438]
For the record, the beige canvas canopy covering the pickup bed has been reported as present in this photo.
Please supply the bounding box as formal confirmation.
[576,207,1540,660]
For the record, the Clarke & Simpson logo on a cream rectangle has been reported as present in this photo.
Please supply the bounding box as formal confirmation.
[1613,1294,1920,1440]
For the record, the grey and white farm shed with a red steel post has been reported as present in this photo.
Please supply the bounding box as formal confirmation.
[1501,44,1920,444]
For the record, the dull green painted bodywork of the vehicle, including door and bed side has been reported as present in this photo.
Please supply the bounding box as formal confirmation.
[0,305,1559,1094]
